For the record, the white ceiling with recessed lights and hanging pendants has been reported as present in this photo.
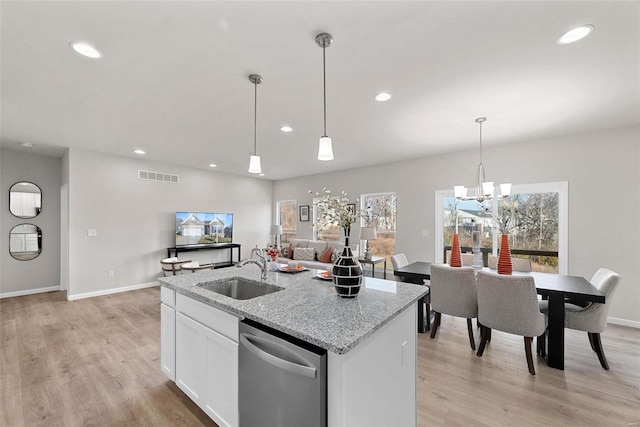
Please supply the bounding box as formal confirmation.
[0,0,640,179]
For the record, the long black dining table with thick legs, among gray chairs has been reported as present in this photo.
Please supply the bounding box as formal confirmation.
[393,261,605,369]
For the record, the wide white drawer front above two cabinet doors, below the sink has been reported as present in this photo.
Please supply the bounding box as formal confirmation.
[176,294,239,343]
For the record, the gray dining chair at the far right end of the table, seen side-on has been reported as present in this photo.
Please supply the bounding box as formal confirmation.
[539,268,620,370]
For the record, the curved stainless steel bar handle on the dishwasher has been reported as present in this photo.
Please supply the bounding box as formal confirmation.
[240,333,317,378]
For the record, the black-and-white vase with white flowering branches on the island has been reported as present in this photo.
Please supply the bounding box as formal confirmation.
[309,188,364,298]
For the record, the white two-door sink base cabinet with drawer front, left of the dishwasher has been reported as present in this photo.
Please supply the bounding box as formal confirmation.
[175,294,239,426]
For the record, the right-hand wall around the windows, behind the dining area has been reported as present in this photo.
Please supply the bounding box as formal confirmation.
[274,127,640,327]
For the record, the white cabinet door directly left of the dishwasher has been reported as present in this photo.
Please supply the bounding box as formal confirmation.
[203,329,238,426]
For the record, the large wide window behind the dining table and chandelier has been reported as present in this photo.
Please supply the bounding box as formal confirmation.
[435,182,568,274]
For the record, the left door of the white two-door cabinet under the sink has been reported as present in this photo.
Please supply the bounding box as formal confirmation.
[176,312,208,407]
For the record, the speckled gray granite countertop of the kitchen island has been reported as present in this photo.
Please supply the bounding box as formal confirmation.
[159,264,428,354]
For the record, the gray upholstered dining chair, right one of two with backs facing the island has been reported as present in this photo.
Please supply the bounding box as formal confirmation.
[477,271,547,375]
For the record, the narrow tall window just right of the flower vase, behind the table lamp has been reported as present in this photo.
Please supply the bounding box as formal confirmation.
[360,193,396,266]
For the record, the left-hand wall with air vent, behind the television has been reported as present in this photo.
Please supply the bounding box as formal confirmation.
[65,149,273,299]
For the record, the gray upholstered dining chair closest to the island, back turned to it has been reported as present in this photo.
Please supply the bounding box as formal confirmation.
[430,264,478,350]
